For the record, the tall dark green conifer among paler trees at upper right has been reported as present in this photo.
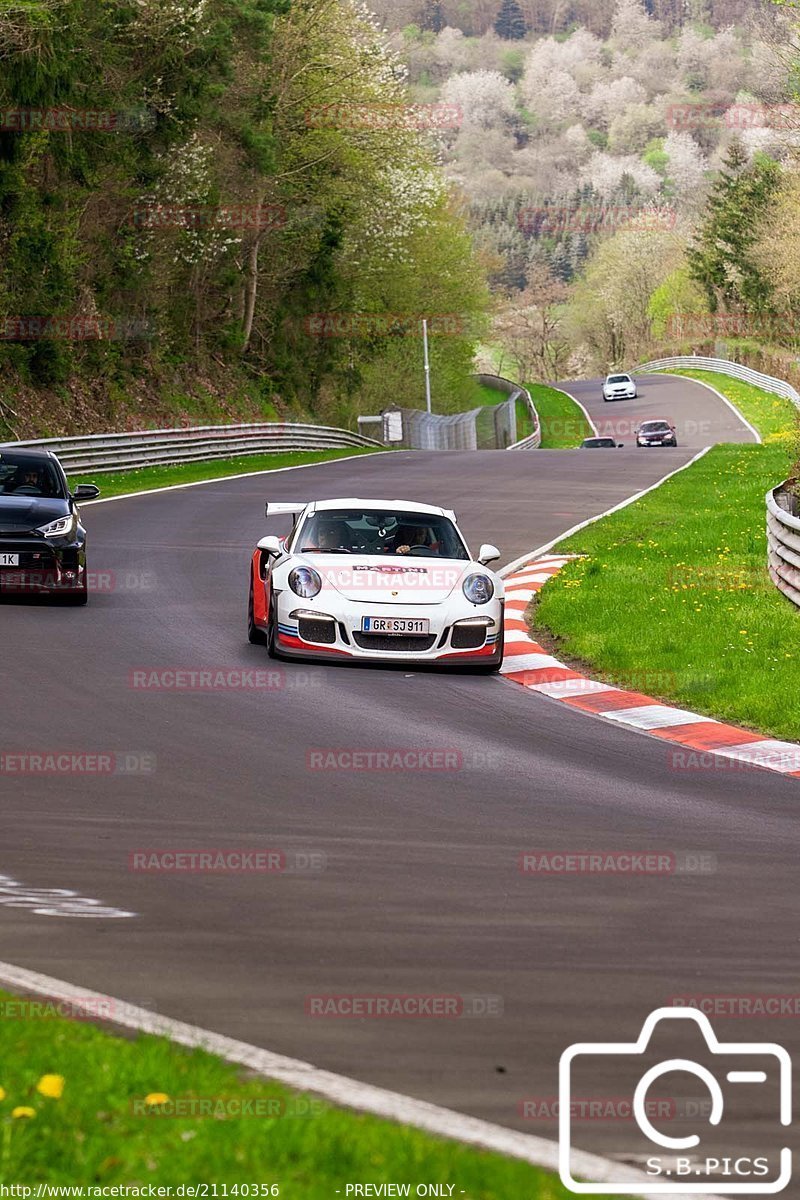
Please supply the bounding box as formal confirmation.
[688,140,781,312]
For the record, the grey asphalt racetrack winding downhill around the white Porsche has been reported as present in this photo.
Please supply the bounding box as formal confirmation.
[0,378,800,1152]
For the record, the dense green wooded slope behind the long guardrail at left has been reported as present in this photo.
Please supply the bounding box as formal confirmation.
[0,0,487,437]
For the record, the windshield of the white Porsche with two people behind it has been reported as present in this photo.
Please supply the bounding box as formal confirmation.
[293,509,469,559]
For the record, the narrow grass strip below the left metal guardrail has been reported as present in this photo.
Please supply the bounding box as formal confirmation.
[70,446,375,497]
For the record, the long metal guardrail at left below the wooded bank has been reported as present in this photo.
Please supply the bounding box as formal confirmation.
[0,421,385,474]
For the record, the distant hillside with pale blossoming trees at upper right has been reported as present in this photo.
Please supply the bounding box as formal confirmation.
[374,0,800,379]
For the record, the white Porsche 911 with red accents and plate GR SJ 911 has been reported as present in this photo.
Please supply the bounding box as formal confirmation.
[247,499,504,671]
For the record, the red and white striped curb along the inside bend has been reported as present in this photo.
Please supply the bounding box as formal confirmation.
[500,554,800,776]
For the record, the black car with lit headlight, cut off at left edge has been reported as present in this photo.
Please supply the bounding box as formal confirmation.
[0,446,100,604]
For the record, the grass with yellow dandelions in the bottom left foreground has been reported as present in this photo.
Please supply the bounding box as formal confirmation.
[0,994,606,1200]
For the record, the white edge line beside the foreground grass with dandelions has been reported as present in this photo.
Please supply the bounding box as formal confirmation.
[0,962,688,1200]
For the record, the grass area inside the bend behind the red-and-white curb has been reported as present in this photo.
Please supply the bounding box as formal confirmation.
[534,372,800,739]
